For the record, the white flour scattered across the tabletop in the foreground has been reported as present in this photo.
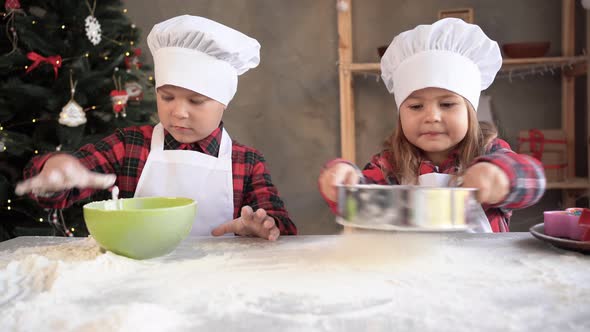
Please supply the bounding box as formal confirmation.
[0,233,590,331]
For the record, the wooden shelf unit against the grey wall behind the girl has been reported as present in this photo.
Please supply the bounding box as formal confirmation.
[336,0,590,206]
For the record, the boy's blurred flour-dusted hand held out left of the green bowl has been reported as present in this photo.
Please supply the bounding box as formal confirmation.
[15,154,117,196]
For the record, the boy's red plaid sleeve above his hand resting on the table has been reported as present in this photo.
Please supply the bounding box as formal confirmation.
[243,151,297,235]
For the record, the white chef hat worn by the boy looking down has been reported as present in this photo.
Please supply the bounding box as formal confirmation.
[147,15,260,106]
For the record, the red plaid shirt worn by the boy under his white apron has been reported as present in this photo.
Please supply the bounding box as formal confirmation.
[24,124,297,235]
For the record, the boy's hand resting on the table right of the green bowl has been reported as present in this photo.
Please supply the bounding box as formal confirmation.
[211,206,280,241]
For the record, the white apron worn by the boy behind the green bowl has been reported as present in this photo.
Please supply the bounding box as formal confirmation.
[134,123,234,235]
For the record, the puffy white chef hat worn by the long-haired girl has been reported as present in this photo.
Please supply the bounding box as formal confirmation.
[381,18,502,110]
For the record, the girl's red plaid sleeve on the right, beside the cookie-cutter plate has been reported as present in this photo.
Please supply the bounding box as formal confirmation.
[474,139,545,209]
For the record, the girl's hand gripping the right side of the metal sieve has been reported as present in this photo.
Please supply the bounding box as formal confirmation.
[462,162,510,204]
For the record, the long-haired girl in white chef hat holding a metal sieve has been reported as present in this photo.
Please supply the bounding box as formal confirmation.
[319,18,545,232]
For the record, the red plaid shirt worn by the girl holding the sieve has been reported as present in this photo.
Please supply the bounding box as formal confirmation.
[324,139,545,232]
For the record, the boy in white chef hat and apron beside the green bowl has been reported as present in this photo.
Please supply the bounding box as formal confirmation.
[16,15,297,240]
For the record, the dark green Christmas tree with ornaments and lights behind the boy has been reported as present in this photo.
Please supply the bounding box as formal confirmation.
[0,0,156,241]
